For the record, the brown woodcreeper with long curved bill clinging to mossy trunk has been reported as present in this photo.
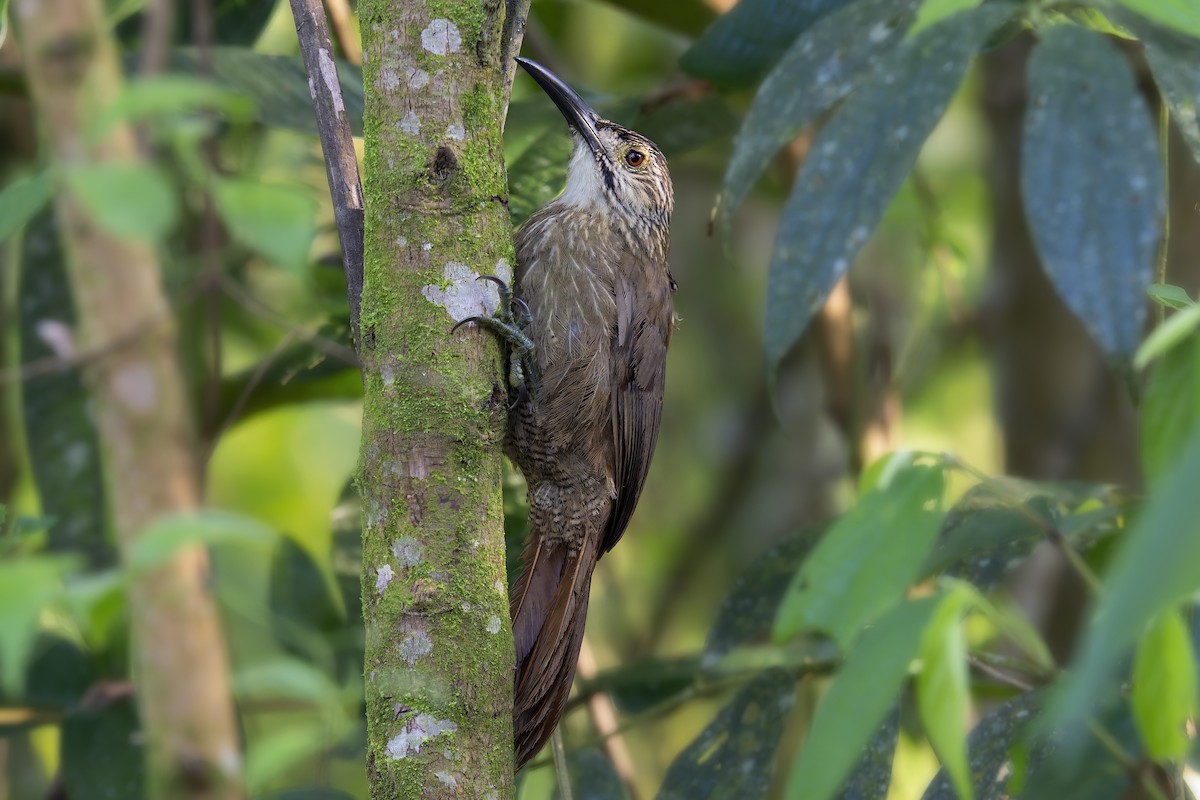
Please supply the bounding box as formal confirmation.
[458,58,676,769]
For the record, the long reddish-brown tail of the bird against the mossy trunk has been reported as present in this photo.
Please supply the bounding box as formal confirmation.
[510,531,599,769]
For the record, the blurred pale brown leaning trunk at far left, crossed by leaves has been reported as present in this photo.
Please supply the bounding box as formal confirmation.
[12,0,242,800]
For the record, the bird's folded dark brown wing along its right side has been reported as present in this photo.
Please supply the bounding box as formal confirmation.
[600,271,673,553]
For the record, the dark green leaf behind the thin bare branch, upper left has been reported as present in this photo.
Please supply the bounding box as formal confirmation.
[170,47,362,136]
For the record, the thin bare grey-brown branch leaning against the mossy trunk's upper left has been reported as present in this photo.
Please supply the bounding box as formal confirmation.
[290,0,364,349]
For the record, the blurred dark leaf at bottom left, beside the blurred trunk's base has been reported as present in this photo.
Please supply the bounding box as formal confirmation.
[61,692,145,800]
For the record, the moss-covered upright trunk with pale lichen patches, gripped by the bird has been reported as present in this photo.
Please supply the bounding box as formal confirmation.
[359,0,514,799]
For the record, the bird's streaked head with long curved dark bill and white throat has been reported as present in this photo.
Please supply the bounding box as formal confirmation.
[517,59,674,224]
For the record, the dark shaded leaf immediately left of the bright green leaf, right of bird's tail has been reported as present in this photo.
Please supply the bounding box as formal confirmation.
[703,525,824,667]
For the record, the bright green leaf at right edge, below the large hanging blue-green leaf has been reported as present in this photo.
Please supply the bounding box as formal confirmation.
[1140,336,1200,486]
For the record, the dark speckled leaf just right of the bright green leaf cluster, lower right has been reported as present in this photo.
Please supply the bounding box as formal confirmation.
[920,477,1124,590]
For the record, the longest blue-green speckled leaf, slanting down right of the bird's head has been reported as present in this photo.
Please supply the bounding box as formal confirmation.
[758,4,1013,375]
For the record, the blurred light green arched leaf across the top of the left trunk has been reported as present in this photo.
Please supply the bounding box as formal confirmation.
[90,73,254,139]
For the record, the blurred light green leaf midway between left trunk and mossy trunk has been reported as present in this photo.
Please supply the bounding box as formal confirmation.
[212,179,317,269]
